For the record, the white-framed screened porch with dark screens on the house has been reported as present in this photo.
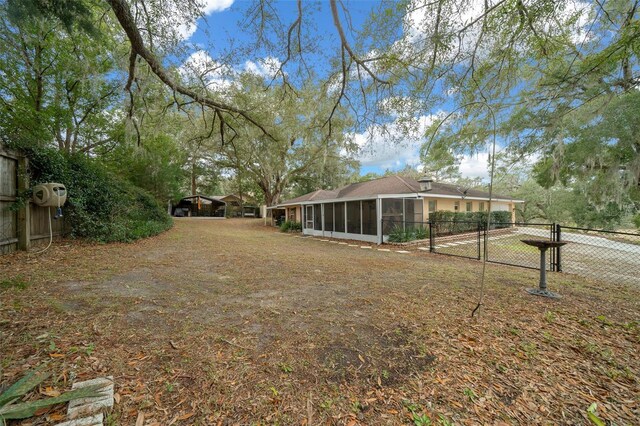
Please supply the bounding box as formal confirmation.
[301,195,423,243]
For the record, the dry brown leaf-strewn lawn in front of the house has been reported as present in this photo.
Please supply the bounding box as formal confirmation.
[0,219,640,426]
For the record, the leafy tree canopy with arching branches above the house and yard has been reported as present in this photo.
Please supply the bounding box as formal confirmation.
[0,0,640,228]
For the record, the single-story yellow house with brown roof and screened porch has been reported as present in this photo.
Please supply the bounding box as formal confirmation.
[270,175,523,244]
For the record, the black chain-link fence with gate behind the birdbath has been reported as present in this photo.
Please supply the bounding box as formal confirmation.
[385,221,640,284]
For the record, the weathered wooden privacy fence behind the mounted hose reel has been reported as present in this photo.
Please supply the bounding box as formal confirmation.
[0,146,65,254]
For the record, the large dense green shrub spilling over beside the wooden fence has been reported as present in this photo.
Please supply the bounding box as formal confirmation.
[22,149,173,242]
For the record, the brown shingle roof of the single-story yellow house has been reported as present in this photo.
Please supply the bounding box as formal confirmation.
[280,175,513,205]
